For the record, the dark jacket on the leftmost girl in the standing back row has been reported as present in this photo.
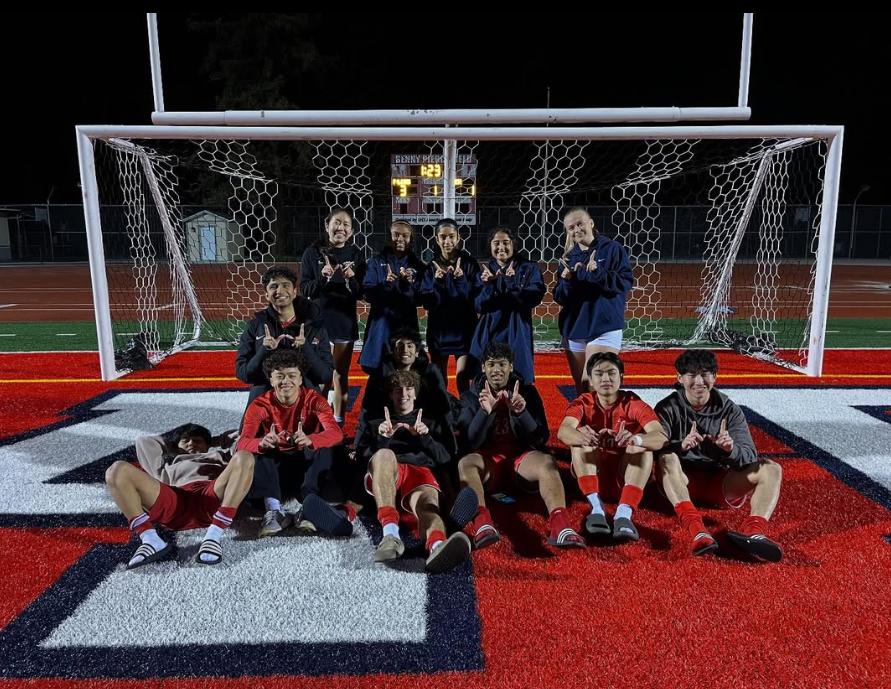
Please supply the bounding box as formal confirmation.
[300,239,365,342]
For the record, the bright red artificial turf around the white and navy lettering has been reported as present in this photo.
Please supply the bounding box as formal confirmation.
[0,352,891,689]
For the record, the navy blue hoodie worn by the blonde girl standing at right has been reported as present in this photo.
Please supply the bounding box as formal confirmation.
[554,235,634,342]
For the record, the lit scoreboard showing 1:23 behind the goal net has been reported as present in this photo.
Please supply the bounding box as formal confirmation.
[390,154,476,225]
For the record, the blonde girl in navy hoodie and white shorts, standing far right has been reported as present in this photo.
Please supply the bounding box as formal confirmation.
[554,206,634,395]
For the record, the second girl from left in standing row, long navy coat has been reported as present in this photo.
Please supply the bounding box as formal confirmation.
[359,220,424,373]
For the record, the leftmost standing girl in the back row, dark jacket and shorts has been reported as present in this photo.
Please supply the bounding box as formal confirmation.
[300,208,365,425]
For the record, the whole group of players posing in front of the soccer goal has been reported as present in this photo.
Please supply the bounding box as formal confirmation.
[106,208,781,572]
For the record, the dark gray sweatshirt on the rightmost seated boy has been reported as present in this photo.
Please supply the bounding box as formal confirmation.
[655,386,758,467]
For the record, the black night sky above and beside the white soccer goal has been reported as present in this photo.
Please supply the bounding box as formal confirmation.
[0,13,891,204]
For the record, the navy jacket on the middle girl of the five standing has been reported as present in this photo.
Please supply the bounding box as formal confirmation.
[421,249,480,356]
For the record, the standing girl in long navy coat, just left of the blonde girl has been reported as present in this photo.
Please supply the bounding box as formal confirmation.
[470,227,545,383]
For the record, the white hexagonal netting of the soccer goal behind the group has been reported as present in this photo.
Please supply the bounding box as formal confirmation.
[90,134,827,376]
